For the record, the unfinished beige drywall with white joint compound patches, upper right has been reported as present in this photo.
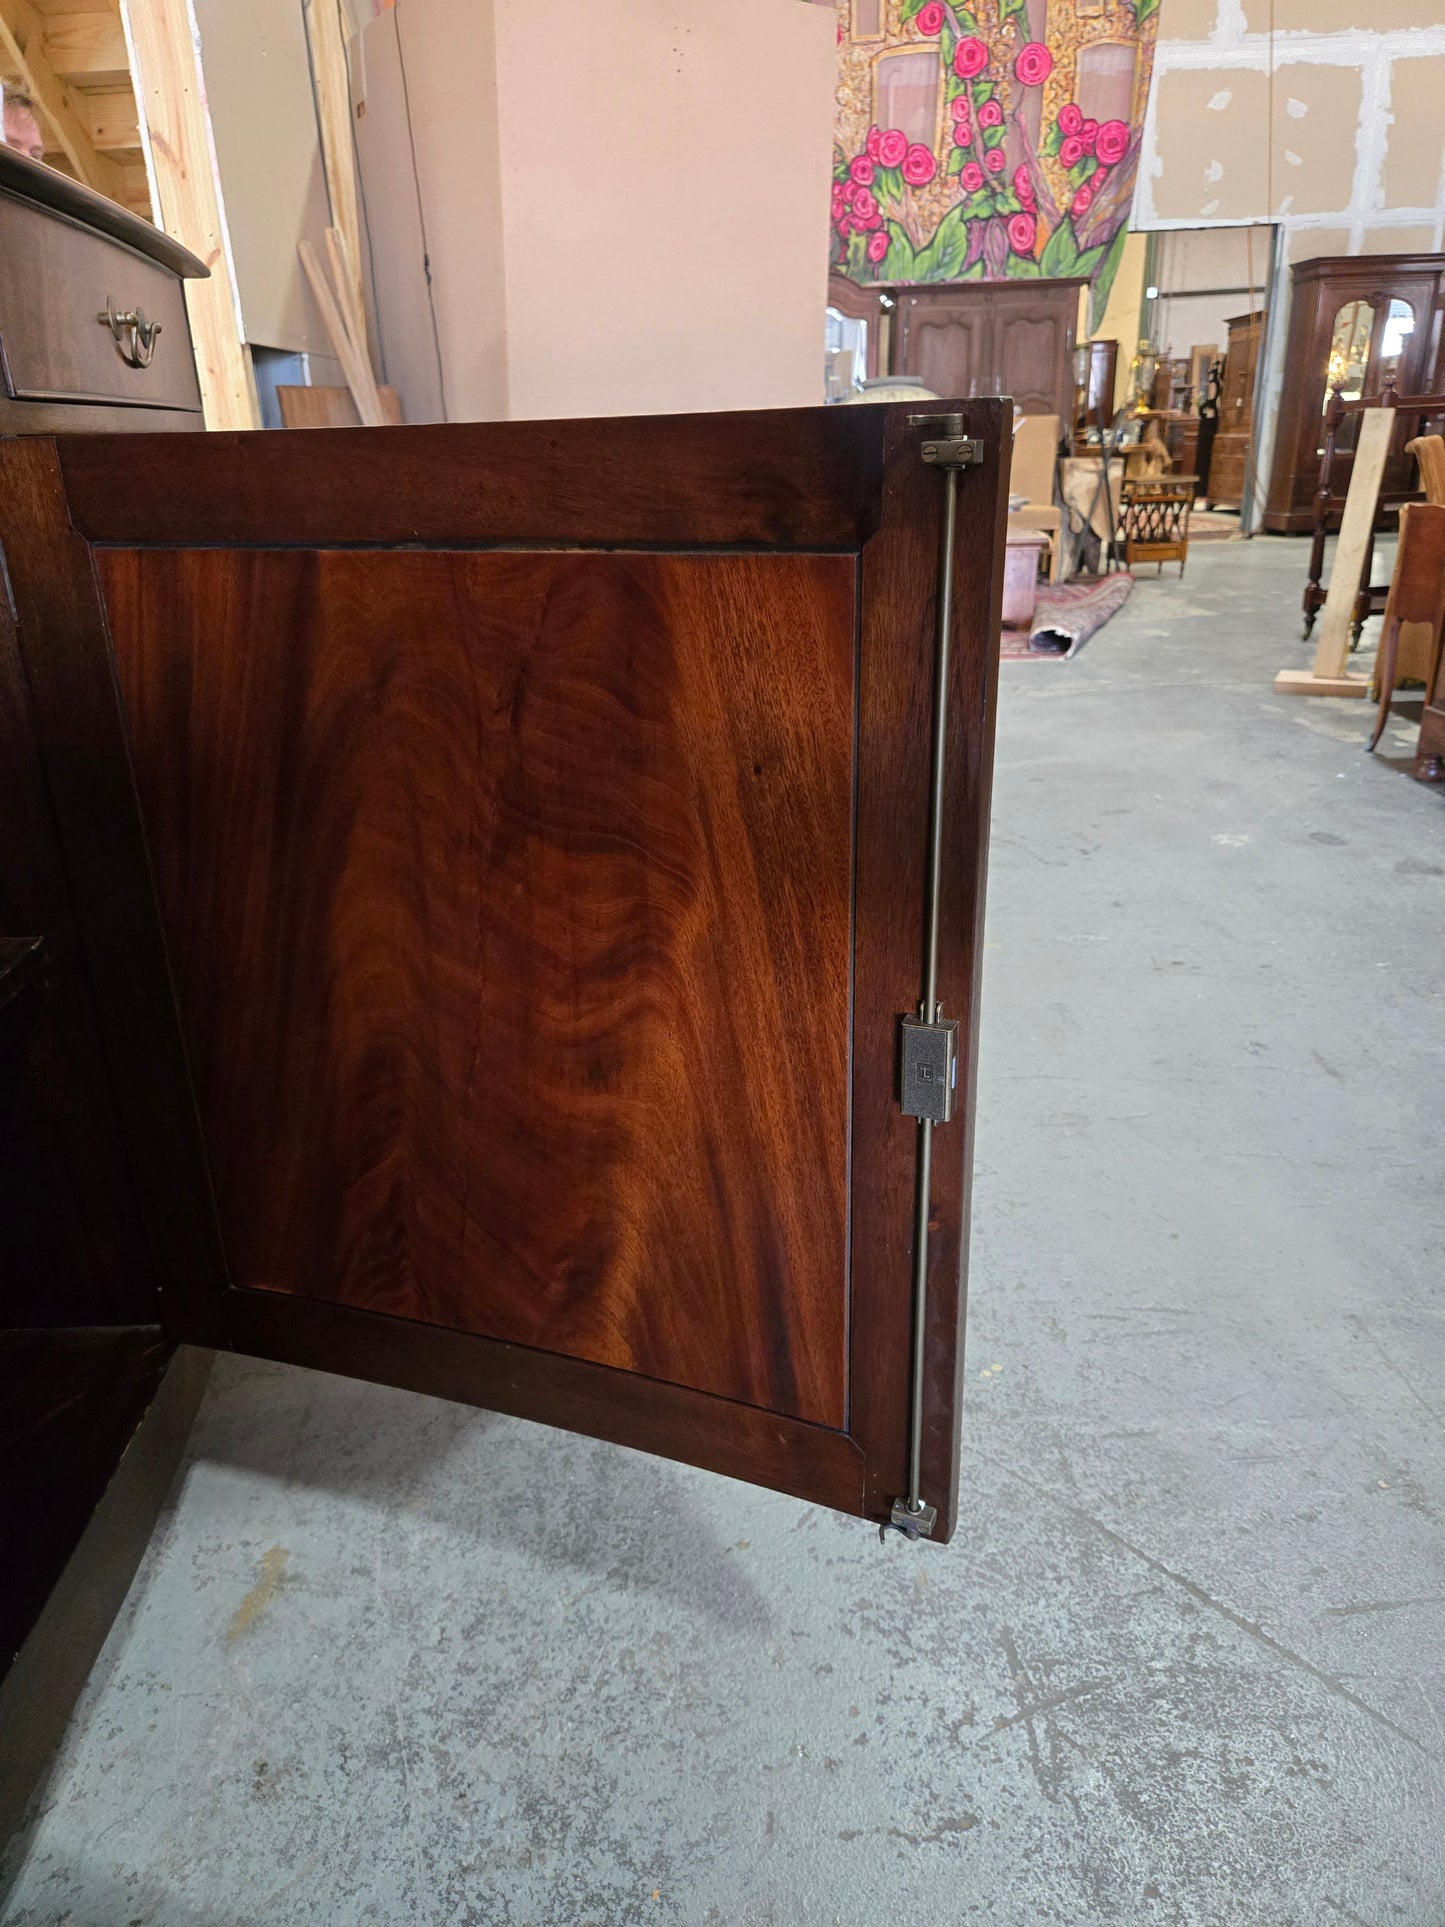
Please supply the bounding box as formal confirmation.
[1135,0,1445,260]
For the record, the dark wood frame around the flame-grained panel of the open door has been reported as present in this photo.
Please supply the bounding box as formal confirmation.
[0,399,1012,1540]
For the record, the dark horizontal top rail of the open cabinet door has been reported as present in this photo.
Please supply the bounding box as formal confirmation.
[60,409,884,549]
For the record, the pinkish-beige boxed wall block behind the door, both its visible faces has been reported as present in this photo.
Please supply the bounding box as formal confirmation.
[353,0,836,420]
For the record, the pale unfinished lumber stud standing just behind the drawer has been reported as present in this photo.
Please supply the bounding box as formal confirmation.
[121,0,260,428]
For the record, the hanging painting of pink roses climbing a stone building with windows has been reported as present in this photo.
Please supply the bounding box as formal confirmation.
[830,0,1158,304]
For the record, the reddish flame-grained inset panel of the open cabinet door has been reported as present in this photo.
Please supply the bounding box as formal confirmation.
[100,549,855,1426]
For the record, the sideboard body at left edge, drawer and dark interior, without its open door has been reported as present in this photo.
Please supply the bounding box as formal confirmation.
[0,146,206,1827]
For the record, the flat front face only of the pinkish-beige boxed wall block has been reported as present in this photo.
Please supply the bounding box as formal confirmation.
[497,0,836,416]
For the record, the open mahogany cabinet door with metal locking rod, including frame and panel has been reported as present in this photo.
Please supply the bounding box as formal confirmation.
[0,401,1008,1540]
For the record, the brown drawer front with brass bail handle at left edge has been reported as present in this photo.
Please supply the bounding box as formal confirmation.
[0,197,200,410]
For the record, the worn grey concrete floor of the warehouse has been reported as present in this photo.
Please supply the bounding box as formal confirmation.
[0,541,1445,1927]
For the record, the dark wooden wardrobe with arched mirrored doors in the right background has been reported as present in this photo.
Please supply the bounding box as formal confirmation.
[1263,254,1445,534]
